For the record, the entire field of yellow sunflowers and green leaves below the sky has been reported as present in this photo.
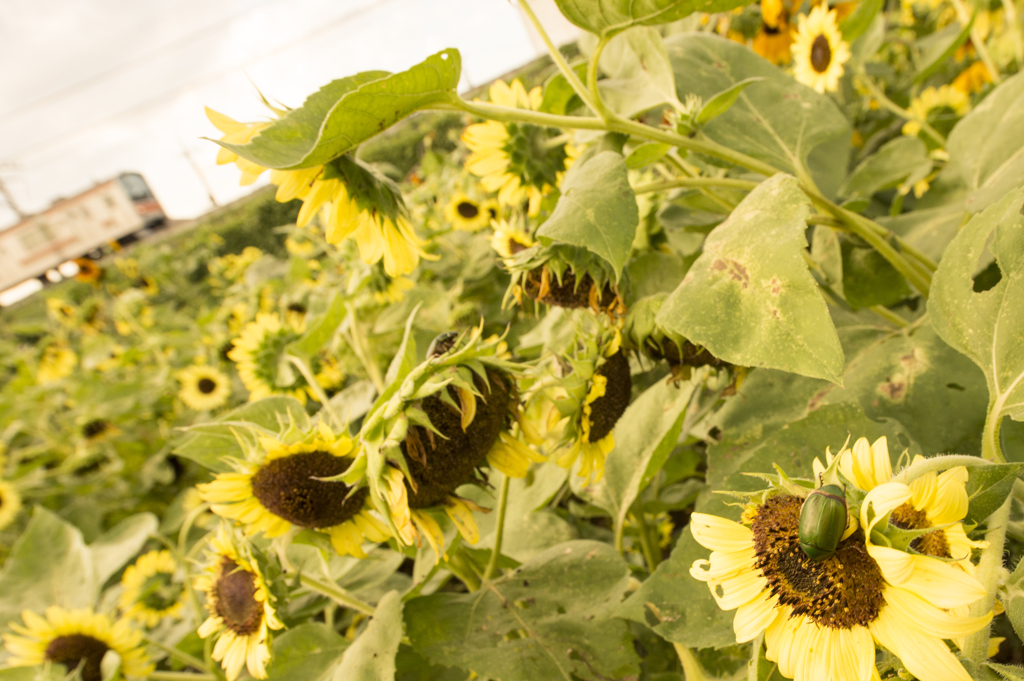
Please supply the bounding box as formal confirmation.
[0,0,1024,681]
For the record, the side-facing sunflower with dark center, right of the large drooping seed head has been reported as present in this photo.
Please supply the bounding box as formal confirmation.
[558,331,632,482]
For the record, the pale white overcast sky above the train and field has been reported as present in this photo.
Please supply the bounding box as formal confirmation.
[0,0,570,228]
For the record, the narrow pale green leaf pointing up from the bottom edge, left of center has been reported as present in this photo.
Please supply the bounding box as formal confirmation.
[334,591,402,681]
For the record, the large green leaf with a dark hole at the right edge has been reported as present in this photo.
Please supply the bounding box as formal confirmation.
[929,189,1024,446]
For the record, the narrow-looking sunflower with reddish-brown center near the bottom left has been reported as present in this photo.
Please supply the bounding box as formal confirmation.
[196,525,284,681]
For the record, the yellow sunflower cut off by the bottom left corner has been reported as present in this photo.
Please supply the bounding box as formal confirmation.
[3,605,153,681]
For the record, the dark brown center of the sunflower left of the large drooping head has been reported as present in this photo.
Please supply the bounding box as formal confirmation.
[253,452,369,527]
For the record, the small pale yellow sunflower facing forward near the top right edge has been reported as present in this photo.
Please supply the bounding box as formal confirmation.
[792,4,850,93]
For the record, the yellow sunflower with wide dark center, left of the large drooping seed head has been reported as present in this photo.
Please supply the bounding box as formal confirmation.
[197,426,389,558]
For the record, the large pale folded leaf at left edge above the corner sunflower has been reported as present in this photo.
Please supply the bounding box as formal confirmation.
[0,506,157,630]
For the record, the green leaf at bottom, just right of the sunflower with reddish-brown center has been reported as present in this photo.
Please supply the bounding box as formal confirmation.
[266,622,350,681]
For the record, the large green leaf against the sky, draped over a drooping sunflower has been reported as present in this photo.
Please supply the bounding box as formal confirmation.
[217,48,462,169]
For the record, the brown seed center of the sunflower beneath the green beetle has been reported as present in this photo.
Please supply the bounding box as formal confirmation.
[751,495,885,629]
